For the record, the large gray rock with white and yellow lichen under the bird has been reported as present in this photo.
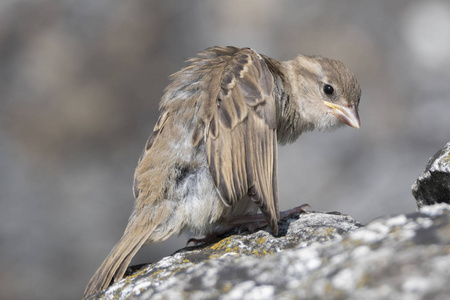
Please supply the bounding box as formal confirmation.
[87,204,450,299]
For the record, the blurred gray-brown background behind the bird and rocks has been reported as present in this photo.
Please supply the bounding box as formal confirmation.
[0,0,450,299]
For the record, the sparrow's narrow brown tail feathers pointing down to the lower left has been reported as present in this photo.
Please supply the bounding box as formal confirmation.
[83,219,156,299]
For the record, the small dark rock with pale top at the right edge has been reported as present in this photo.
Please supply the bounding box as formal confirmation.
[412,142,450,208]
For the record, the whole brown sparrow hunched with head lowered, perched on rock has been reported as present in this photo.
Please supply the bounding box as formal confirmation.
[83,46,361,299]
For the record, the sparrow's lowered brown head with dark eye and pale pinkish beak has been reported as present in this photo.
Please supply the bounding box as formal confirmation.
[284,55,361,130]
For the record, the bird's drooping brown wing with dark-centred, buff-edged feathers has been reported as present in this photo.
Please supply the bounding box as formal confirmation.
[205,48,279,233]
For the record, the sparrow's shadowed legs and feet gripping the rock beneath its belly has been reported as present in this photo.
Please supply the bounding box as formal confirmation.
[187,204,310,245]
